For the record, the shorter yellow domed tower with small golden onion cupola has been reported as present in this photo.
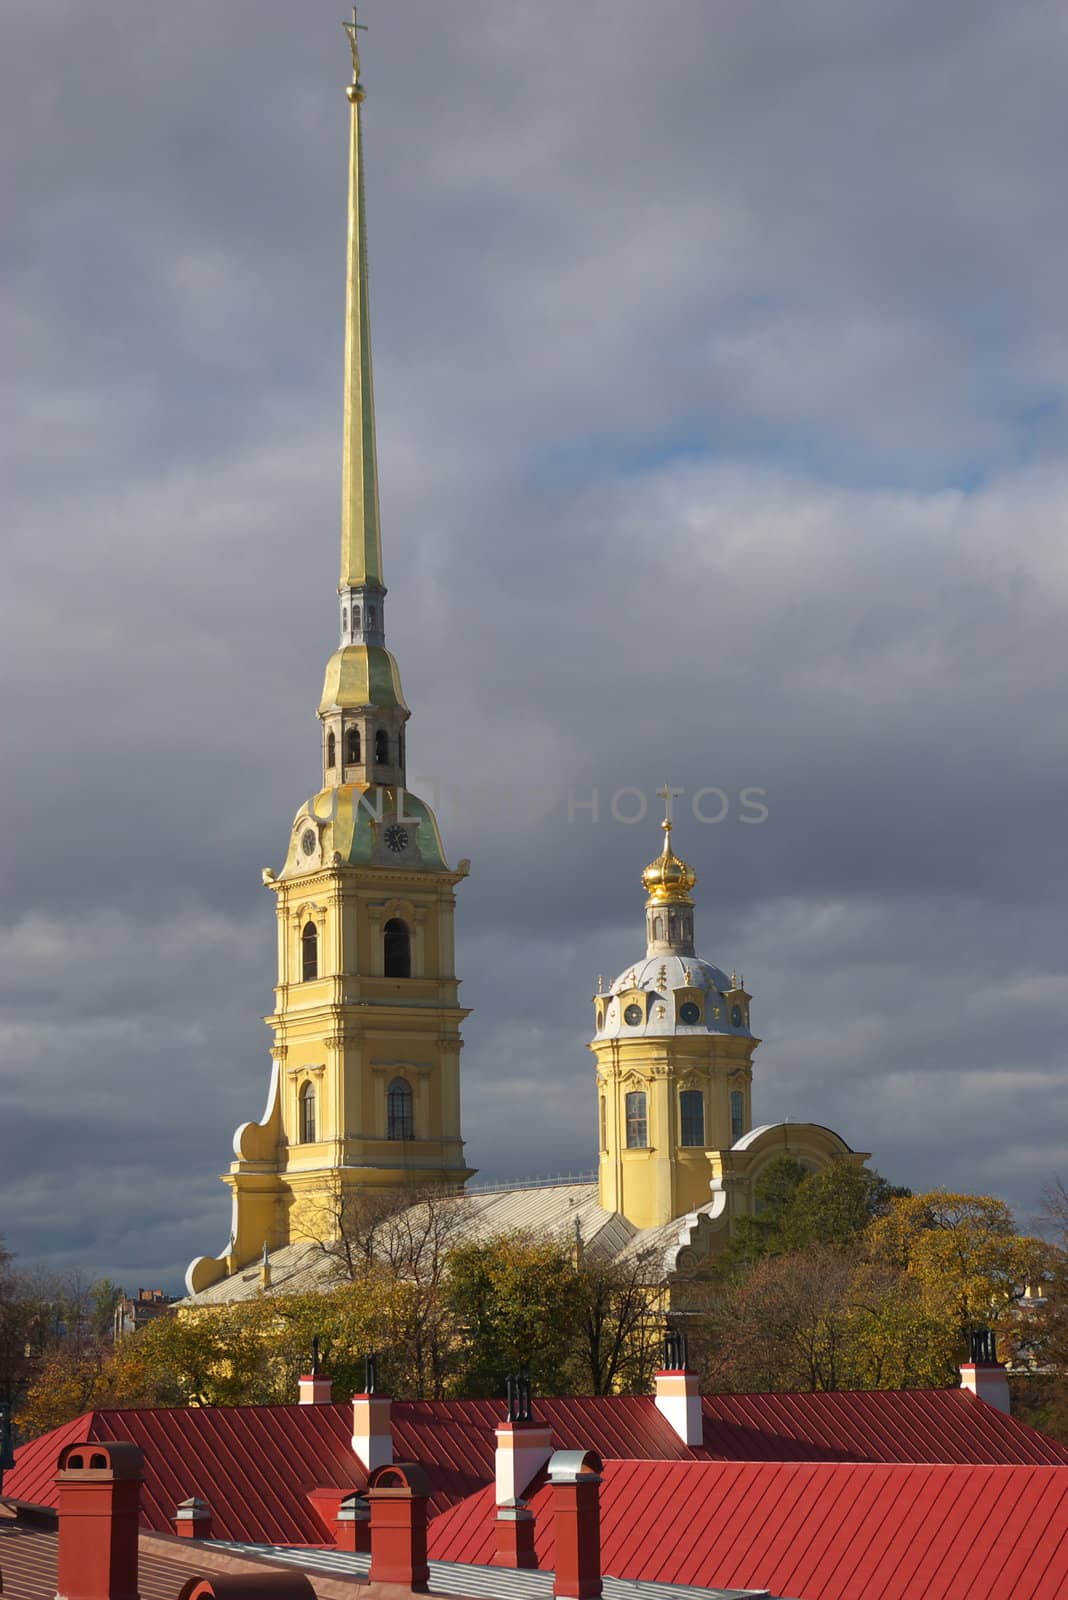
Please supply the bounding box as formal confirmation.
[590,806,759,1227]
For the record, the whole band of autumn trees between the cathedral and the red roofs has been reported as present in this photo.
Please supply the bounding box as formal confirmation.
[12,1177,1068,1434]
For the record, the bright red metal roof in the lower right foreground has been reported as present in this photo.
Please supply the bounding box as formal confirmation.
[430,1461,1068,1600]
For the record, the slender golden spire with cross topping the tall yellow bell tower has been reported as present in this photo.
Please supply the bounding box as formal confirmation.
[339,6,382,589]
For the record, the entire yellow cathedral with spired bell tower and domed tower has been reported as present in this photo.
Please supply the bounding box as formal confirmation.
[187,21,867,1304]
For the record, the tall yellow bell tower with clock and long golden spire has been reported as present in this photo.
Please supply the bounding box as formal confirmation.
[187,10,472,1293]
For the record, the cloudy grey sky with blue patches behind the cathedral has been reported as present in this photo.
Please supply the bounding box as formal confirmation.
[0,0,1068,1286]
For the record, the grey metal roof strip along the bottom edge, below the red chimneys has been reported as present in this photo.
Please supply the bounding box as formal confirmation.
[211,1539,775,1600]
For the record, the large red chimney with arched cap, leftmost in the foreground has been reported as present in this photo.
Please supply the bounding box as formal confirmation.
[56,1443,142,1600]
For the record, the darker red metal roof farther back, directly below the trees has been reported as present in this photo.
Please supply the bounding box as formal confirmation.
[5,1389,1068,1544]
